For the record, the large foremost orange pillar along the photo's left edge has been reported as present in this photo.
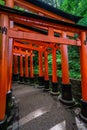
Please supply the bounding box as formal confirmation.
[0,14,9,130]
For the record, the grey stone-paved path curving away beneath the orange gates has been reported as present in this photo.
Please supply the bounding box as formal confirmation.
[13,83,87,130]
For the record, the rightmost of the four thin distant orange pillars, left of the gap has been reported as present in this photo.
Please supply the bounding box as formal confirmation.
[30,52,34,83]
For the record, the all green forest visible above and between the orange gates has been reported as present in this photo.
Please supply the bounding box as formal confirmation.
[0,0,87,79]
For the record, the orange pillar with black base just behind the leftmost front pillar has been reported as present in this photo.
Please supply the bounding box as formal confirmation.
[6,38,13,118]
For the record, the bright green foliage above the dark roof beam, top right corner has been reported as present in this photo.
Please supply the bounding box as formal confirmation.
[40,0,87,26]
